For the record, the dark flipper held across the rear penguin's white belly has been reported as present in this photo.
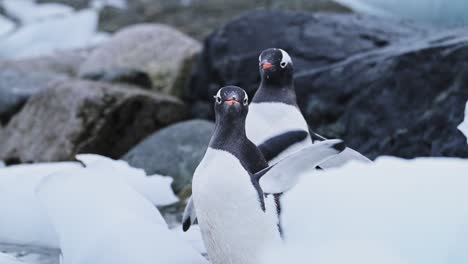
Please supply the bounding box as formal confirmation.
[258,130,308,162]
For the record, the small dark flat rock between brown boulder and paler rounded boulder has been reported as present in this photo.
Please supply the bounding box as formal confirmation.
[82,68,153,90]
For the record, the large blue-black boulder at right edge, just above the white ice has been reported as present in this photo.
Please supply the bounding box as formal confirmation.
[296,30,468,158]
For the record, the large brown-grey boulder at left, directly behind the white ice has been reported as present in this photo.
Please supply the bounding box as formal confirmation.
[0,80,186,163]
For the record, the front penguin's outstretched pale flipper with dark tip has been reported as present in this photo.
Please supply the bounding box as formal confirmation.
[254,139,346,194]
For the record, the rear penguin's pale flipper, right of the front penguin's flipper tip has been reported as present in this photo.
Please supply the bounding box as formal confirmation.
[309,130,372,169]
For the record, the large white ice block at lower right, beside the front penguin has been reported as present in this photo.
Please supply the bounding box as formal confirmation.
[264,157,468,264]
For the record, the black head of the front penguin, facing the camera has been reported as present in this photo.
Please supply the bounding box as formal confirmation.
[214,86,249,120]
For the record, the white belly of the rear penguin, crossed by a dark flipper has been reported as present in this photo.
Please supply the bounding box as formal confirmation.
[245,102,312,164]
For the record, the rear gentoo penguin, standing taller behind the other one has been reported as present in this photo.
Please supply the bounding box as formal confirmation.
[246,48,371,165]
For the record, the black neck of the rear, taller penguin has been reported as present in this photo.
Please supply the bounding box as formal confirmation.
[252,78,297,106]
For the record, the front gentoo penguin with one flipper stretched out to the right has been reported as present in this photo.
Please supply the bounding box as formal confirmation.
[192,86,344,264]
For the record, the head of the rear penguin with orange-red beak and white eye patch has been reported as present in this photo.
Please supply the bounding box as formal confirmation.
[258,48,294,84]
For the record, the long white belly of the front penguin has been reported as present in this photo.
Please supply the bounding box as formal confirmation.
[192,148,281,264]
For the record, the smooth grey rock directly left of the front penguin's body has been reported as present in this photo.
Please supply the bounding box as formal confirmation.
[122,120,214,194]
